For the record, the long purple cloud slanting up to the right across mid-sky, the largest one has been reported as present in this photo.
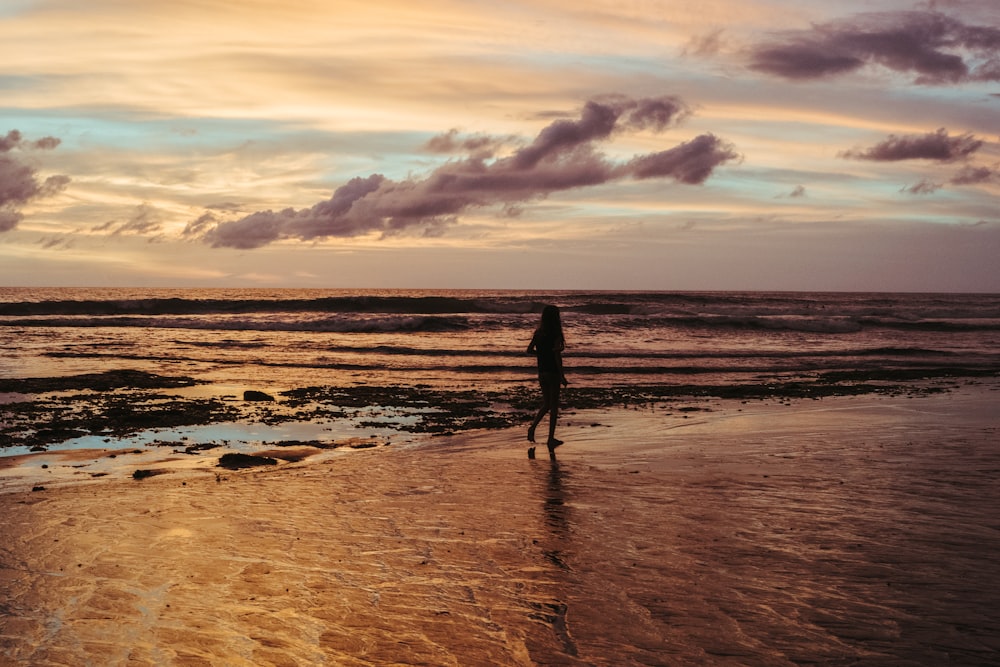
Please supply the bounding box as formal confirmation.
[201,96,739,248]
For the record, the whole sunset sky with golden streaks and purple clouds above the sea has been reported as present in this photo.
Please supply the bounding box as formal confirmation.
[0,0,1000,292]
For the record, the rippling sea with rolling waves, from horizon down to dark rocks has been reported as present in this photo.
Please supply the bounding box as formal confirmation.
[0,288,1000,392]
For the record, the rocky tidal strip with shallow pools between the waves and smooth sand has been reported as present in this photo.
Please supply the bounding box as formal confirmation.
[0,371,996,493]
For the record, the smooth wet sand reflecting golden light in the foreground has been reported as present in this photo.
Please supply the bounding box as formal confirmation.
[0,384,1000,665]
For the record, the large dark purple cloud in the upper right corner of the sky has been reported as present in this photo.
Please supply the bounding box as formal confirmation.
[750,11,1000,84]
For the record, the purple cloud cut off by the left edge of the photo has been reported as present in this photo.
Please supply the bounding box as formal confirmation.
[0,130,70,232]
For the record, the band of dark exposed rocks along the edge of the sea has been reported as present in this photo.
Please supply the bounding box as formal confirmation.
[0,368,996,454]
